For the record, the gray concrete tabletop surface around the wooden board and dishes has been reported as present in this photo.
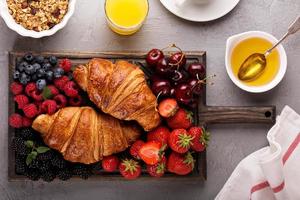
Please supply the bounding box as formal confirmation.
[0,0,300,200]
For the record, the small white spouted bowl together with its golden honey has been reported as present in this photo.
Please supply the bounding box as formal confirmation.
[225,31,287,93]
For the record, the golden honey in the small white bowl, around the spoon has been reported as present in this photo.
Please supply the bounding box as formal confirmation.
[231,37,280,86]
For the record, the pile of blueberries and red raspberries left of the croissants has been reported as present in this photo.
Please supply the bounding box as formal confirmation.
[9,53,82,128]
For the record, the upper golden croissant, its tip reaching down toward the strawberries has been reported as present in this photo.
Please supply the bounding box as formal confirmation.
[73,58,160,131]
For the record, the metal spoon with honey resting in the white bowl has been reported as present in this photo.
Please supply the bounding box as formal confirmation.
[238,16,300,81]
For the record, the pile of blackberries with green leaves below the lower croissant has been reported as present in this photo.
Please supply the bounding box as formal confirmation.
[11,128,95,182]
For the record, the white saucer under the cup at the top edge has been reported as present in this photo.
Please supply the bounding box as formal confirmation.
[160,0,240,22]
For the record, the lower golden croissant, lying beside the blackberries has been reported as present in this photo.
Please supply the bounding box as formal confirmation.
[32,107,140,164]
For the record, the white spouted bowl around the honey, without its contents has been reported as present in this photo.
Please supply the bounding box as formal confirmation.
[225,31,287,93]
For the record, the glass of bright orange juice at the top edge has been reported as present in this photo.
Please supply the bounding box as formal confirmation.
[104,0,149,35]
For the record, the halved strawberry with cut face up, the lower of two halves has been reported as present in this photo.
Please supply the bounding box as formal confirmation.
[139,141,163,165]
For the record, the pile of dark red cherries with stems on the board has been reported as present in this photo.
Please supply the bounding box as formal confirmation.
[146,45,206,107]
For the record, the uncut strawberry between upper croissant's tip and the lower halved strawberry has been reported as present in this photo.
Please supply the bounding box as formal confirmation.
[147,126,170,148]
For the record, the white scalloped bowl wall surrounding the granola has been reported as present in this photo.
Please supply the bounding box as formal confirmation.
[0,0,76,38]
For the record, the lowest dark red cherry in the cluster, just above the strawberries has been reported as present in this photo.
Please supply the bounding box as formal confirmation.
[175,83,193,105]
